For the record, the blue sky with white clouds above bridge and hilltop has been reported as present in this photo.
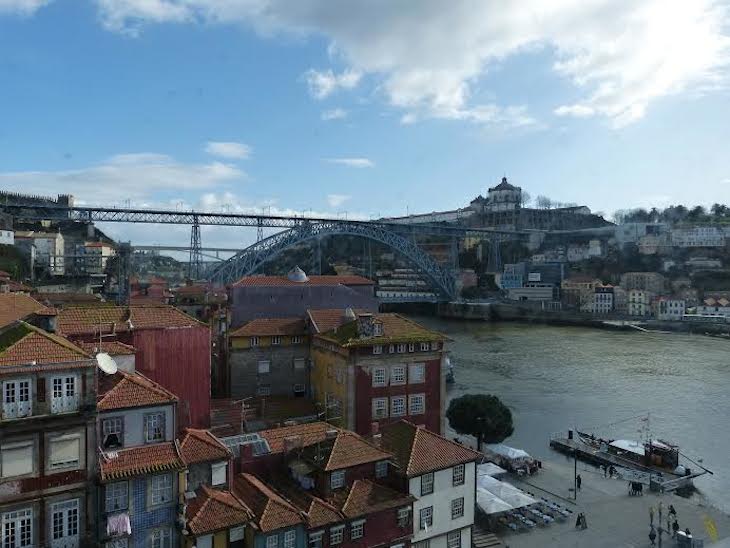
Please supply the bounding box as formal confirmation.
[0,0,730,245]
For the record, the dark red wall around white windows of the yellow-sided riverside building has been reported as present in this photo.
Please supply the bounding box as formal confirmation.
[355,360,441,435]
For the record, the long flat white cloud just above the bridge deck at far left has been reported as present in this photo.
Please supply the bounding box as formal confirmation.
[0,153,246,205]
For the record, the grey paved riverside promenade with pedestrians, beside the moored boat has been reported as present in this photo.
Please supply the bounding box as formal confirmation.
[500,459,730,548]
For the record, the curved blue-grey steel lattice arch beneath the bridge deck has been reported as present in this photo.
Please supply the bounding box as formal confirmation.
[210,220,456,299]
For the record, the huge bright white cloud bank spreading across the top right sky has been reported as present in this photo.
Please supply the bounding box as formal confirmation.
[91,0,730,126]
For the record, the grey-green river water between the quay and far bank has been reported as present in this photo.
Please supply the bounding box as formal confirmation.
[415,317,730,513]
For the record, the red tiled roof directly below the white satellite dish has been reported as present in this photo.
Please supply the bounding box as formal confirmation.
[96,371,177,411]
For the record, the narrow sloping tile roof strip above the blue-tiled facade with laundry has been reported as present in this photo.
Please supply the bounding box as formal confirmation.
[99,441,185,481]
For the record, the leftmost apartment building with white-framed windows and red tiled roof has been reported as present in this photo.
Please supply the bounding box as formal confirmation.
[0,321,96,548]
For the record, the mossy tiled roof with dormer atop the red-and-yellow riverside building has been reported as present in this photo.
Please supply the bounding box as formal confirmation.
[318,313,447,347]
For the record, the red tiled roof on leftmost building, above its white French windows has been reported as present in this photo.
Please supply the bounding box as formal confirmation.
[0,322,91,367]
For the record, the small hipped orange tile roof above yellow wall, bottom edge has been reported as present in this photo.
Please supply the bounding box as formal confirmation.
[185,485,253,535]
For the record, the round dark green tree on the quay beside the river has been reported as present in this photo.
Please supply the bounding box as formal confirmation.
[446,394,514,450]
